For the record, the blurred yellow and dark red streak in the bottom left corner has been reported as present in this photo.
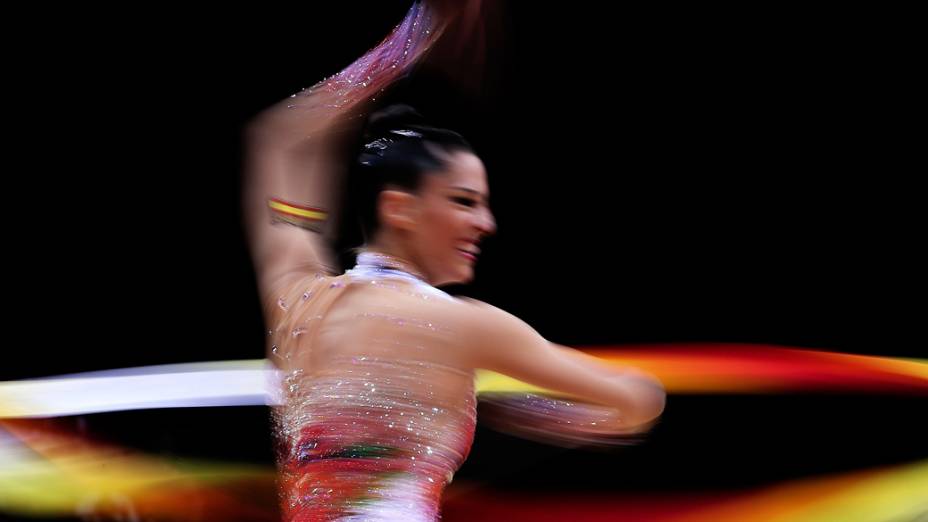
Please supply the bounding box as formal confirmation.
[0,419,276,521]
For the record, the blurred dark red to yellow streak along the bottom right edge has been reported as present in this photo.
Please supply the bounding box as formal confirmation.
[443,460,928,522]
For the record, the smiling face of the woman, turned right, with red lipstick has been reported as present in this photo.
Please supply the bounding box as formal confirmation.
[410,151,496,286]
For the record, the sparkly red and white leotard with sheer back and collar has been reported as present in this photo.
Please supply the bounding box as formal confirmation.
[266,252,476,521]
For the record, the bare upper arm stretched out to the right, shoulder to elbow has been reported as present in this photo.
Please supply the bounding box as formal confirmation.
[465,300,666,428]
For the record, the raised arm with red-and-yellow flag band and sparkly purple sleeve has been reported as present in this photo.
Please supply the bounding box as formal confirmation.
[243,0,473,294]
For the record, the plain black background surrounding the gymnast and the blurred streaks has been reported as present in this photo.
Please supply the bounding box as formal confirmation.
[0,2,926,516]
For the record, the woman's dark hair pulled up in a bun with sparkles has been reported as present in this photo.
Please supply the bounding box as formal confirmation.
[350,105,473,240]
